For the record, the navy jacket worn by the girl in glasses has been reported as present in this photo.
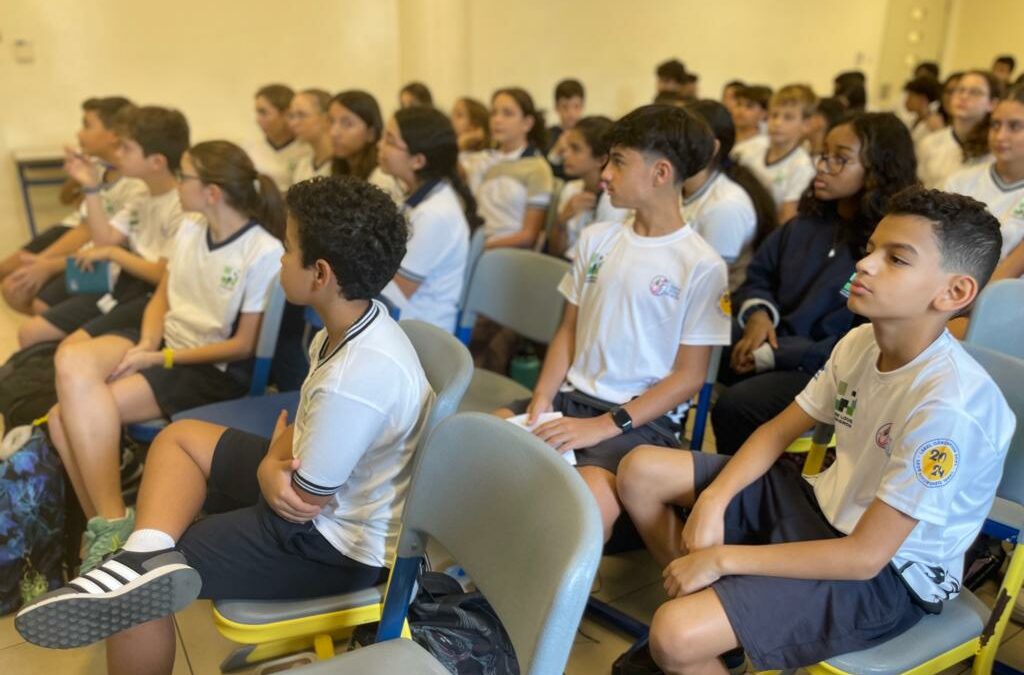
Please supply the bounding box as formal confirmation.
[732,215,864,373]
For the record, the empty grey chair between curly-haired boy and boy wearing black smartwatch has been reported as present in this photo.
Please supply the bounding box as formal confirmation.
[459,249,569,413]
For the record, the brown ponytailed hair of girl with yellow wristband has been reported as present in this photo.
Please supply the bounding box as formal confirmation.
[188,140,285,241]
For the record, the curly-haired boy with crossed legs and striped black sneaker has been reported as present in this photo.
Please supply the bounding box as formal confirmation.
[15,177,434,674]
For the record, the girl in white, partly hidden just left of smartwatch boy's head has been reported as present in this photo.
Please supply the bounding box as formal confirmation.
[548,116,629,260]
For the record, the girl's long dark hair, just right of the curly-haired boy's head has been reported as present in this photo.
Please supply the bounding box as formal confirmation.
[394,107,483,231]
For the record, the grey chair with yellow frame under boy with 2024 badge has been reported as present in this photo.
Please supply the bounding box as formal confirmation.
[774,344,1024,675]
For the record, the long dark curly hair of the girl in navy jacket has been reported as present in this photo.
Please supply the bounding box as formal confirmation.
[798,113,918,257]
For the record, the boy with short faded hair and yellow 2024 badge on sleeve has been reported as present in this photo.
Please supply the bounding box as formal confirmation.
[618,187,1016,673]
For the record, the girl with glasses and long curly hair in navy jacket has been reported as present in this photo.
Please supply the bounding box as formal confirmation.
[712,113,916,455]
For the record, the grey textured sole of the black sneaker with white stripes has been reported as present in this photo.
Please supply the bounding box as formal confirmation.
[14,564,202,649]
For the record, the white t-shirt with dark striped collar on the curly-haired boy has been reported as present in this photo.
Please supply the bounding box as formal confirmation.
[292,301,434,566]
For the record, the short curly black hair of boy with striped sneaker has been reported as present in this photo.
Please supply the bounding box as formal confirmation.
[286,176,409,300]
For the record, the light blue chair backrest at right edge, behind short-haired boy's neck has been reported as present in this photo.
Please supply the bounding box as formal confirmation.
[965,279,1024,358]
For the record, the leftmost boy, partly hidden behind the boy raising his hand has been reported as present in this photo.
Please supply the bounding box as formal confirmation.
[0,96,146,313]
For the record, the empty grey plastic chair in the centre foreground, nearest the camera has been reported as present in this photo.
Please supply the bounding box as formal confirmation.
[295,414,602,675]
